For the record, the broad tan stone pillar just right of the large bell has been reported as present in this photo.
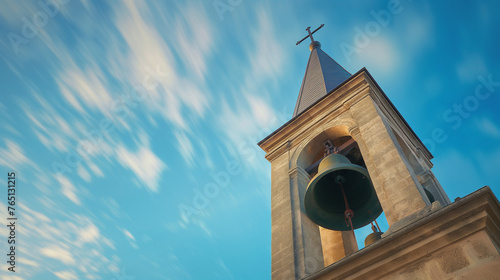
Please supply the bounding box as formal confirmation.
[349,94,427,225]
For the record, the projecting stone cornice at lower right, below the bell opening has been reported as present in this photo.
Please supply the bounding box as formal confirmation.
[304,187,500,280]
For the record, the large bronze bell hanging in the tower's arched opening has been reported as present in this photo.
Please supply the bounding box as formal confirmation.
[304,154,382,231]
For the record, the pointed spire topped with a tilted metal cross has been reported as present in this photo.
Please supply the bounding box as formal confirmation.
[293,24,351,117]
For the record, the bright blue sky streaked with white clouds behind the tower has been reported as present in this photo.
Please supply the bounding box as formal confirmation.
[0,0,500,280]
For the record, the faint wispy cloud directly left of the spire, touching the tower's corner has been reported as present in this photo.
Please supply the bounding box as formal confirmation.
[213,6,293,173]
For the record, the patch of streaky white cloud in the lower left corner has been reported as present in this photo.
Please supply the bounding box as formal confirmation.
[11,203,114,279]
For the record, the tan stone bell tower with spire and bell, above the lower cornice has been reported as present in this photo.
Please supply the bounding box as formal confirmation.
[258,25,498,279]
